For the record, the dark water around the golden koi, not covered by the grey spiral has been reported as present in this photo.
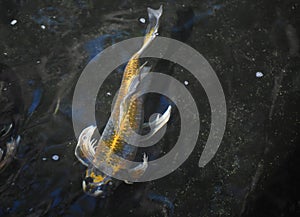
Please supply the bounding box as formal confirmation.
[0,0,300,217]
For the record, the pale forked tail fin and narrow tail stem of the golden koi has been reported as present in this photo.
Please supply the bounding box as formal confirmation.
[137,5,163,55]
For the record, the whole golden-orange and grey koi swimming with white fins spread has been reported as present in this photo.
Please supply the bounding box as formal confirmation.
[75,6,171,197]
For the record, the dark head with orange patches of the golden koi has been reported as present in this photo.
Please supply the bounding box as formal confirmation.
[82,167,115,198]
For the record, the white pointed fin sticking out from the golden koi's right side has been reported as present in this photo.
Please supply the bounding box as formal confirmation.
[142,105,172,140]
